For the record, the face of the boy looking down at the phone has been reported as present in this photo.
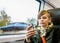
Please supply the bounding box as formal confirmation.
[38,13,51,27]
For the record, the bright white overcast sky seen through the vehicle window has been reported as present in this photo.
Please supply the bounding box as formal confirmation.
[0,0,39,22]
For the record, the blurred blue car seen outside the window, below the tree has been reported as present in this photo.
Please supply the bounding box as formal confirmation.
[0,22,27,34]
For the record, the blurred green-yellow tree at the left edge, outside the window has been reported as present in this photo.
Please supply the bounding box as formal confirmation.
[0,10,11,26]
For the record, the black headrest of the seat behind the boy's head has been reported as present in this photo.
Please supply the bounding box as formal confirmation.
[48,8,60,25]
